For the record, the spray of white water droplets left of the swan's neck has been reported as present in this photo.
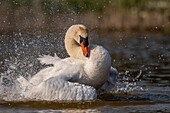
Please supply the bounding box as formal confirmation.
[0,33,67,101]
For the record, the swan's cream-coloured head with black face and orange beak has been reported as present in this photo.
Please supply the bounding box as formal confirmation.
[65,24,90,57]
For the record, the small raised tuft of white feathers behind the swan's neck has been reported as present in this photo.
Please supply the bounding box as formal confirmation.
[38,53,61,65]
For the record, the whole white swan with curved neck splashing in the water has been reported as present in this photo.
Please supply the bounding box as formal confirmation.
[18,24,117,100]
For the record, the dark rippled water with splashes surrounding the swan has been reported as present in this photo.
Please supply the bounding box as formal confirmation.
[0,33,170,113]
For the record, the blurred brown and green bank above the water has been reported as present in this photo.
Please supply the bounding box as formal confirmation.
[0,0,170,34]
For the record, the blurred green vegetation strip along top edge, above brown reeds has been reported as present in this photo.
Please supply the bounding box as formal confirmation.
[4,0,170,15]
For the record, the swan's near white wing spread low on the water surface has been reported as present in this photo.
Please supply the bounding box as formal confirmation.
[25,77,97,100]
